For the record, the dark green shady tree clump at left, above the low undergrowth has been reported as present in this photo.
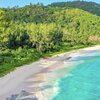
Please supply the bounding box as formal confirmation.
[7,30,31,49]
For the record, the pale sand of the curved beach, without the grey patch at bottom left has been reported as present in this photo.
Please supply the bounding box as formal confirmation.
[0,45,100,100]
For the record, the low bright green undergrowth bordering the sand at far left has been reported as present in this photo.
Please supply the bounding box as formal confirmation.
[0,48,42,77]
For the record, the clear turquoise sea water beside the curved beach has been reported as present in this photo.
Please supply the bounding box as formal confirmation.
[52,52,100,100]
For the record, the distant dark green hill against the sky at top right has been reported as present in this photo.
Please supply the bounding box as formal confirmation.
[50,1,100,16]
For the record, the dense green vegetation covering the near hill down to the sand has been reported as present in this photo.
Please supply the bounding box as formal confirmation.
[0,0,100,76]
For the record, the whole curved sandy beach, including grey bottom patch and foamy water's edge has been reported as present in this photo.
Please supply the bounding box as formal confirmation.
[0,45,100,100]
